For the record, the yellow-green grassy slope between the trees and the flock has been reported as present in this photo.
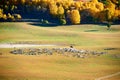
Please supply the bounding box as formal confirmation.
[0,22,120,46]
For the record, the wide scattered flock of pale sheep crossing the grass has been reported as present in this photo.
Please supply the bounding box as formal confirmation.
[10,47,106,58]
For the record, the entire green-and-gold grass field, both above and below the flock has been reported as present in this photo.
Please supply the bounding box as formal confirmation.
[0,22,120,80]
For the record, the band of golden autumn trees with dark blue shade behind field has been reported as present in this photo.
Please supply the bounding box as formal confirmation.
[0,0,120,24]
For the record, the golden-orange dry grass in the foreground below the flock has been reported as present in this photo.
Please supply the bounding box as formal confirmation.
[0,49,120,80]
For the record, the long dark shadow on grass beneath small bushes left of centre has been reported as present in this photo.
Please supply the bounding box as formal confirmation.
[28,22,59,27]
